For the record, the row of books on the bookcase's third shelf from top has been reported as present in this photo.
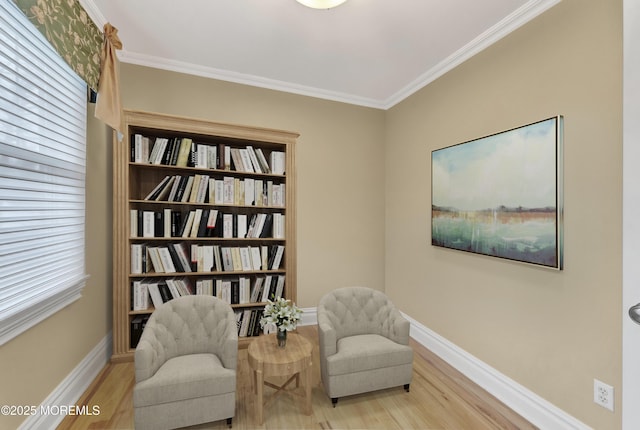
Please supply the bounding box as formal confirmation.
[129,208,286,239]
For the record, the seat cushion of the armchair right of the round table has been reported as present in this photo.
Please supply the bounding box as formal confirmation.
[327,334,413,376]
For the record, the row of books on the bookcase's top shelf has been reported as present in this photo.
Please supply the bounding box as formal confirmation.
[131,133,285,175]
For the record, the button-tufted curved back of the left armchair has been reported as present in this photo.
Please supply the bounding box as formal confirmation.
[135,295,238,382]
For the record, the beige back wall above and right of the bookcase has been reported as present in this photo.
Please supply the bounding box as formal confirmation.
[122,64,385,307]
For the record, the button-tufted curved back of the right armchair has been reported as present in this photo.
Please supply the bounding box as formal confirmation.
[318,287,409,344]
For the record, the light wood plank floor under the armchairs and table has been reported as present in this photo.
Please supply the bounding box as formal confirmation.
[58,326,536,430]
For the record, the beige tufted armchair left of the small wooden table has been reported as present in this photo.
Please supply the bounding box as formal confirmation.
[133,295,238,430]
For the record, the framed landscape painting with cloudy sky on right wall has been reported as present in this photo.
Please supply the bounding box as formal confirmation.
[431,116,563,270]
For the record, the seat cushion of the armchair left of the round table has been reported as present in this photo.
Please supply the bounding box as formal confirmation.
[133,354,236,407]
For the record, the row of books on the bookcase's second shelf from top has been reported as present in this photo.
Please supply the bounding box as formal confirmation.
[144,174,286,207]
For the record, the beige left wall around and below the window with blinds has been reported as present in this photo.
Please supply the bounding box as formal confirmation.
[0,105,111,429]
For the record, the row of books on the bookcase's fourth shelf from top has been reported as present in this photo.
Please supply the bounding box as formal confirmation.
[131,242,284,274]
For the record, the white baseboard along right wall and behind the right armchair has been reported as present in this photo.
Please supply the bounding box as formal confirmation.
[300,308,590,430]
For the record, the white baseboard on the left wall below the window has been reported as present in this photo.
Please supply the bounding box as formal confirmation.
[18,332,112,430]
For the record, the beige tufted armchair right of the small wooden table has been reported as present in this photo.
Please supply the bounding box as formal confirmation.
[318,287,413,407]
